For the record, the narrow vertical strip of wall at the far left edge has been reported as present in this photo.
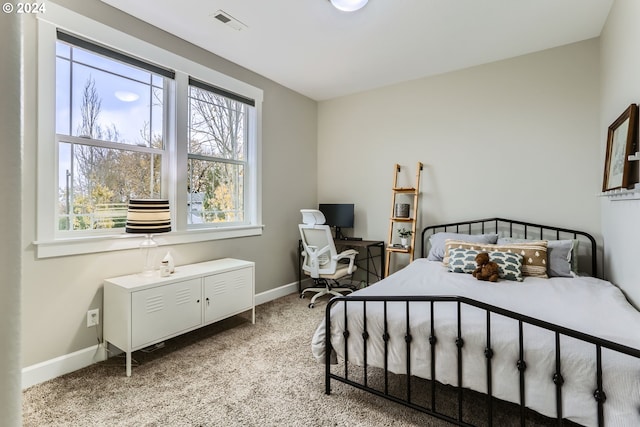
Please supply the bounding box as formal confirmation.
[0,6,22,427]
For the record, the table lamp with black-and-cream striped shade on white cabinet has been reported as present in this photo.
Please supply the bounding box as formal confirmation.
[125,199,171,276]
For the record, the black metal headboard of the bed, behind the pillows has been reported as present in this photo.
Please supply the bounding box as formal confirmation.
[421,218,599,277]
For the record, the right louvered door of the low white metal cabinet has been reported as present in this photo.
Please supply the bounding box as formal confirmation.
[203,267,254,323]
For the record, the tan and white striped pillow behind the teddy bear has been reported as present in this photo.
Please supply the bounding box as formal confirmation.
[442,239,548,279]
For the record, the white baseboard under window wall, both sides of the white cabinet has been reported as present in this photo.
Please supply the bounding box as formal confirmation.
[22,282,298,390]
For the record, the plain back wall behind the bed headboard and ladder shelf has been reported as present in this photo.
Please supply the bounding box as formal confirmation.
[318,39,602,268]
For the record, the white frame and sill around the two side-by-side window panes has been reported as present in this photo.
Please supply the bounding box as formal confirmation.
[34,4,263,258]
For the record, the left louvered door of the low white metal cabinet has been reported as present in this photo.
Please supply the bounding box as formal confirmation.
[131,278,202,348]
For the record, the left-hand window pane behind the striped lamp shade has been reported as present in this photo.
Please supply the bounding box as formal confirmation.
[56,32,173,232]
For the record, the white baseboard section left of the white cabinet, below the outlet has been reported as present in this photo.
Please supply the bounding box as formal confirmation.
[22,344,107,390]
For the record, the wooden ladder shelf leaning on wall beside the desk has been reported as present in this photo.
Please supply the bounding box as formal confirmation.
[384,162,423,277]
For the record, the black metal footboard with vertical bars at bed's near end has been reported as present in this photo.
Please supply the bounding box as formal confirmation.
[325,295,640,426]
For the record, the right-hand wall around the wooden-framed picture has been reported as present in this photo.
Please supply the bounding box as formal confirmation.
[599,0,640,308]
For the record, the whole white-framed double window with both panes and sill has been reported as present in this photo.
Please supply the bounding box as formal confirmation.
[35,4,262,257]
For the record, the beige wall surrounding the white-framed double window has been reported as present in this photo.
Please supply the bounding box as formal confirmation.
[20,0,317,372]
